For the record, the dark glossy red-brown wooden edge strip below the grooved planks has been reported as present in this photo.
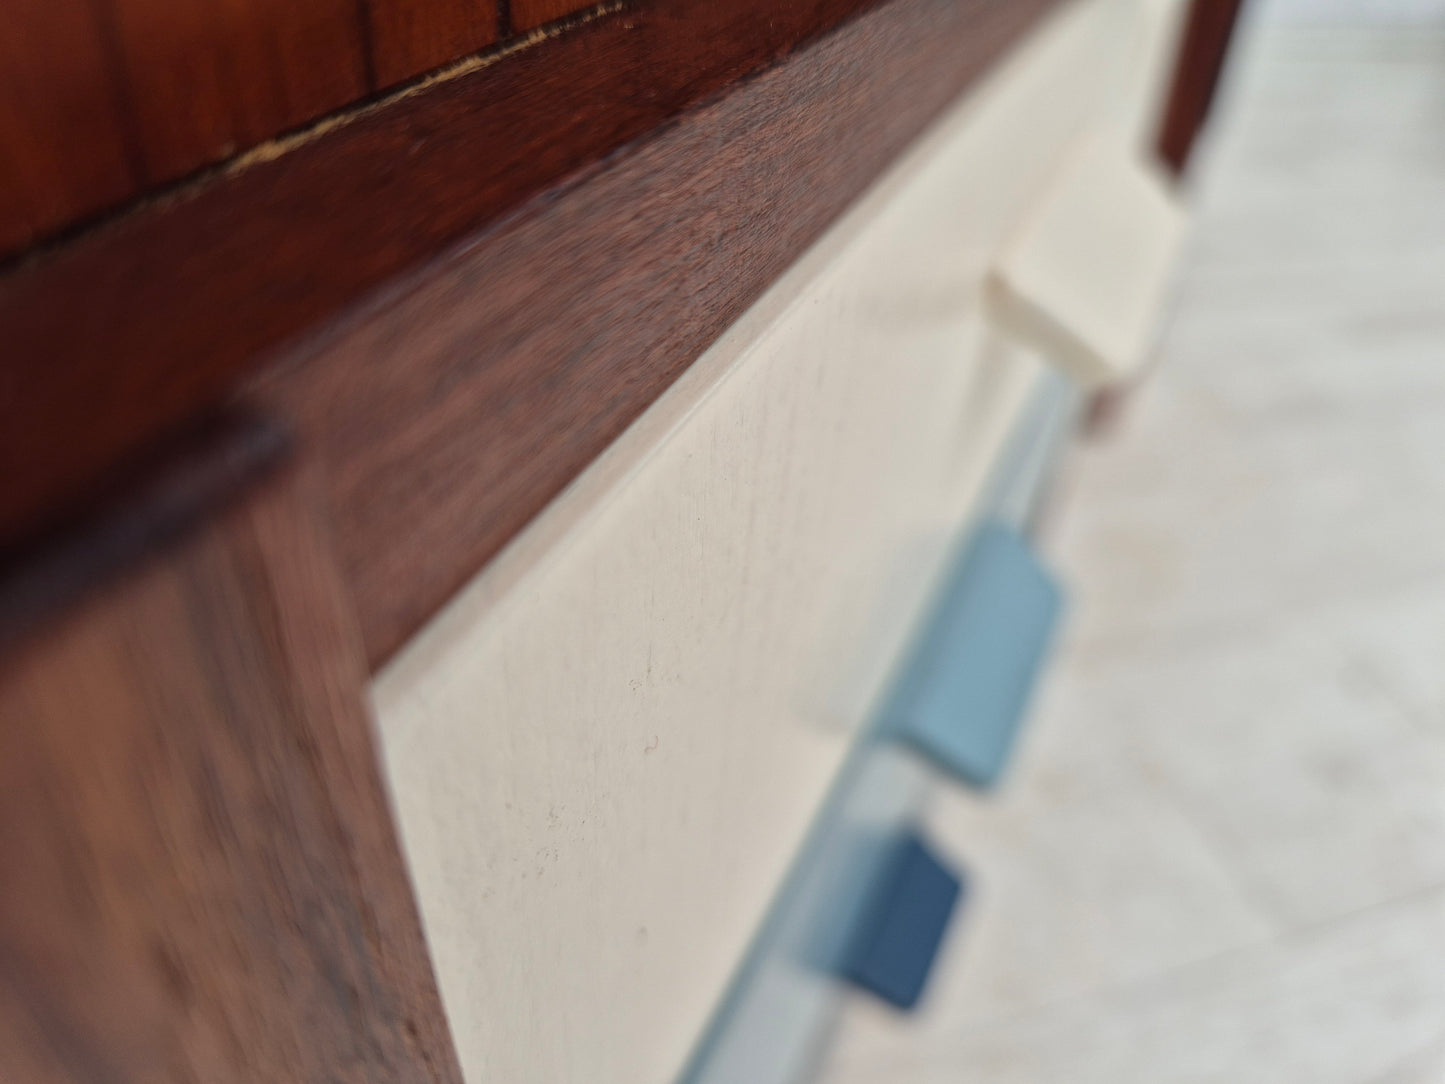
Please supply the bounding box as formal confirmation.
[0,0,901,560]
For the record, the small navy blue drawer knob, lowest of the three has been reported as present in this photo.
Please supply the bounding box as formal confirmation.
[841,833,962,1009]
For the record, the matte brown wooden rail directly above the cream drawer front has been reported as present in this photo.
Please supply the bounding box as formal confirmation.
[273,0,1048,665]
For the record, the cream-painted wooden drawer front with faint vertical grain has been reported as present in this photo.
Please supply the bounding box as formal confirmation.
[373,0,1179,1084]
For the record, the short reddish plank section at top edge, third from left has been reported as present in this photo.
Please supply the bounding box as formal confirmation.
[366,0,501,87]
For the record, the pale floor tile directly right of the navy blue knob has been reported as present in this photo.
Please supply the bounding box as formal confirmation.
[848,774,1274,1051]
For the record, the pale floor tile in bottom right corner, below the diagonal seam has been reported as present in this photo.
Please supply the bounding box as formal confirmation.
[825,890,1445,1084]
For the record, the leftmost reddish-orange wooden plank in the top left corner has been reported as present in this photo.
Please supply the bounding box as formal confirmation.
[0,0,140,253]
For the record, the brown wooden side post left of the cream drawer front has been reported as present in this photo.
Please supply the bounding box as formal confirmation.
[0,459,460,1084]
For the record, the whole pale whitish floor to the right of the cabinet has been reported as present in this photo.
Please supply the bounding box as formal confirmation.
[824,8,1445,1084]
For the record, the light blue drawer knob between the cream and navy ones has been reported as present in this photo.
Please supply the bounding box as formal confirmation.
[886,523,1062,786]
